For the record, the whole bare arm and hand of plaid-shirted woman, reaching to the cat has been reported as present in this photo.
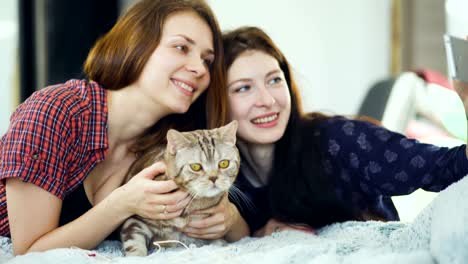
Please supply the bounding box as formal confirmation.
[6,163,189,255]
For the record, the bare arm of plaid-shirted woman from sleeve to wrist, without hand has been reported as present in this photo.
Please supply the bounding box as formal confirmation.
[6,178,129,255]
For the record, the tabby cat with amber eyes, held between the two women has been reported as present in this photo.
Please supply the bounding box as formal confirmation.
[120,121,240,256]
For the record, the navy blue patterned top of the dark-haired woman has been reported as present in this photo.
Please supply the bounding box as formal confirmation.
[232,117,468,232]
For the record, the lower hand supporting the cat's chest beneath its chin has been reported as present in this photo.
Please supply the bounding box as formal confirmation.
[181,194,240,239]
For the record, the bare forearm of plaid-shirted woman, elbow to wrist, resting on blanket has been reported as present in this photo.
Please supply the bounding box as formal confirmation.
[27,189,130,252]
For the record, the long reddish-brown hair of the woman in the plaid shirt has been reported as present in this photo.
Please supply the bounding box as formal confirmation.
[84,0,227,152]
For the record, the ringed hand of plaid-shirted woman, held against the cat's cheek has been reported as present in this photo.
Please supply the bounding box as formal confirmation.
[119,162,191,220]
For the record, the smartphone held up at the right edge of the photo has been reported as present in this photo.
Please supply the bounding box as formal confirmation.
[444,34,468,83]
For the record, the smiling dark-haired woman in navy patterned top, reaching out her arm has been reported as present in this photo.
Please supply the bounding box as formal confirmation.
[191,27,468,236]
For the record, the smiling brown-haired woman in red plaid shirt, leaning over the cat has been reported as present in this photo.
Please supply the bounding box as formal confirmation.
[0,0,227,254]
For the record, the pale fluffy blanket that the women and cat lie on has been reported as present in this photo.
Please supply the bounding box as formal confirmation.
[0,177,468,264]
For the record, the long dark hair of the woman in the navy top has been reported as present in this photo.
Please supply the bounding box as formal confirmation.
[223,27,359,228]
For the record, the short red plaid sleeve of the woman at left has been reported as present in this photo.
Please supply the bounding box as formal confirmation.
[0,92,75,199]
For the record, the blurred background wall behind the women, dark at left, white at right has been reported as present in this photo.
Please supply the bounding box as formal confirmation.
[0,0,454,133]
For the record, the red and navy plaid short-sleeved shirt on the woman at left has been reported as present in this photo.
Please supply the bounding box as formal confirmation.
[0,80,108,236]
